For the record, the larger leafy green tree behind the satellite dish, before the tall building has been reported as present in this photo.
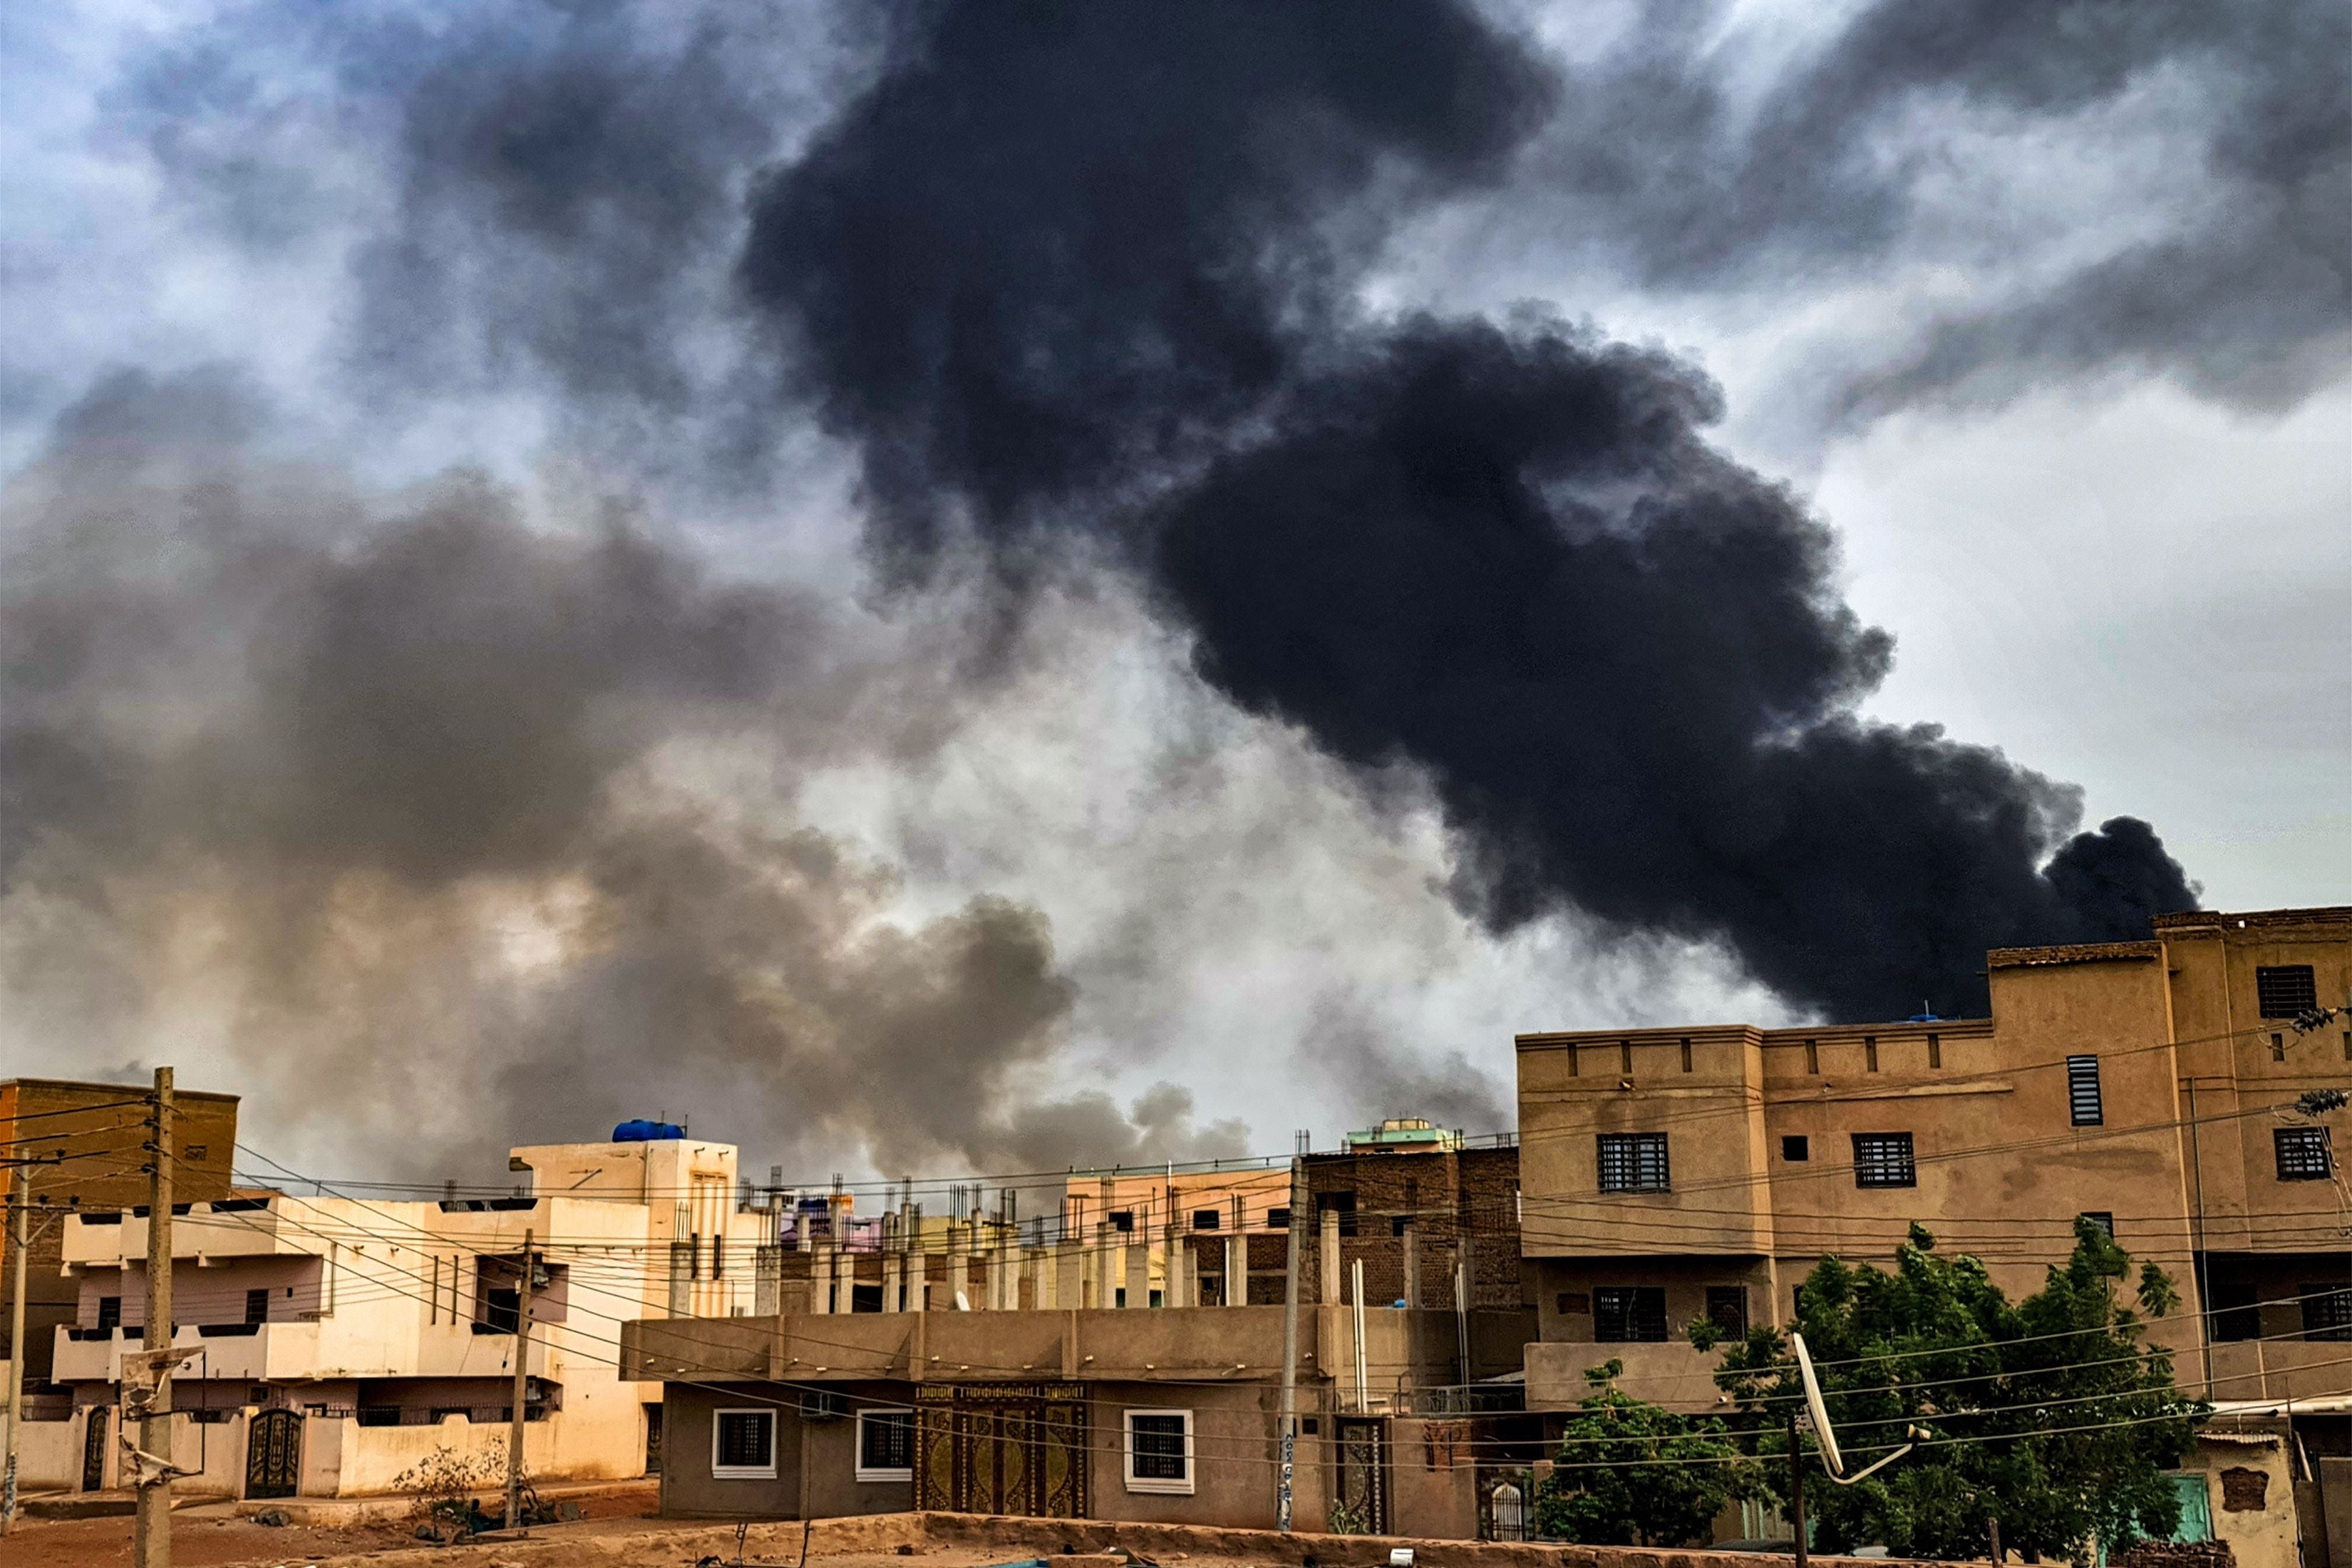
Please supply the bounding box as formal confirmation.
[1691,1220,2206,1563]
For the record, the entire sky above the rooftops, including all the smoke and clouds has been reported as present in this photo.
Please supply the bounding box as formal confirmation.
[0,0,2352,1182]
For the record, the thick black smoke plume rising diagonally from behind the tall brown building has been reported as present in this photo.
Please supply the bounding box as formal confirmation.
[741,2,2192,1018]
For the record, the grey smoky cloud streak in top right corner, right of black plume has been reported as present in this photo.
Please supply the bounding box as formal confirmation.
[1498,0,2352,421]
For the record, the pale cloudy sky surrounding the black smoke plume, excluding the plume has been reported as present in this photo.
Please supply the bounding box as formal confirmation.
[0,0,2352,1180]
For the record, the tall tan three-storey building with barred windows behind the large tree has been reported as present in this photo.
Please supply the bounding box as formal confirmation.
[1517,909,2352,1561]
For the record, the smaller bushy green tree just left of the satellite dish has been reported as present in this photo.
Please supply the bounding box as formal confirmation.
[1536,1361,1755,1547]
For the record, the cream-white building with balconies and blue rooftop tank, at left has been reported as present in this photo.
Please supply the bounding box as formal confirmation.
[24,1128,774,1497]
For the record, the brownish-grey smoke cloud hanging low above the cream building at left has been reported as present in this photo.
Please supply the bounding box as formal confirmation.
[0,373,1242,1173]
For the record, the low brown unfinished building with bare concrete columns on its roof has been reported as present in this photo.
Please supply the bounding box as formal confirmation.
[624,1140,1538,1537]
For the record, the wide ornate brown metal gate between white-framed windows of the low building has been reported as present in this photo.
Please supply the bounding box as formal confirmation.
[915,1385,1087,1519]
